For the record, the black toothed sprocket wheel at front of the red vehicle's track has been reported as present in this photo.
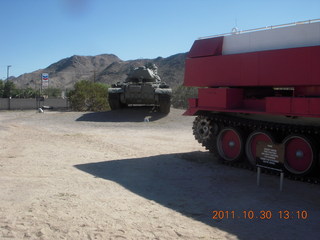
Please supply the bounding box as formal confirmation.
[192,115,219,153]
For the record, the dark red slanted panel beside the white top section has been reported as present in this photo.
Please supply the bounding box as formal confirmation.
[188,37,223,58]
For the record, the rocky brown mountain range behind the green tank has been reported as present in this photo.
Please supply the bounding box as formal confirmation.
[12,53,186,89]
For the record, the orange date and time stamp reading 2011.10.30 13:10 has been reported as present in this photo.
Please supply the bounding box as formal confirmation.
[212,210,308,220]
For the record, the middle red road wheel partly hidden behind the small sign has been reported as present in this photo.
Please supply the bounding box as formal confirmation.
[245,131,274,166]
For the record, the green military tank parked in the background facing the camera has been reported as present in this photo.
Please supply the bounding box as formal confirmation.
[108,64,172,114]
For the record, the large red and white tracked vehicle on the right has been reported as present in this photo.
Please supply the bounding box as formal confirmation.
[184,19,320,175]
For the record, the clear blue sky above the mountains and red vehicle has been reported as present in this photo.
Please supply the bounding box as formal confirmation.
[0,0,320,79]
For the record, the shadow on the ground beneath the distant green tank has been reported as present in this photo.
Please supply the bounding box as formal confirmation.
[77,107,167,122]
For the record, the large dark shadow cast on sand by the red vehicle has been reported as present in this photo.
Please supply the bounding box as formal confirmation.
[75,152,320,239]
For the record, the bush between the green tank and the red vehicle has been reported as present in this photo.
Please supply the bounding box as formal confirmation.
[171,85,198,109]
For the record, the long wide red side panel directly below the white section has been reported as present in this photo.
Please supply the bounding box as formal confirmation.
[185,46,320,87]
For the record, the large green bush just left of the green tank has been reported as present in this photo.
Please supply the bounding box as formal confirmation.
[68,80,110,112]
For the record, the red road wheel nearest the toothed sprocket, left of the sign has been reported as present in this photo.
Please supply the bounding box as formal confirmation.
[217,127,243,162]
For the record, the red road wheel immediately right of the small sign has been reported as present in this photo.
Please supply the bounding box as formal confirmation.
[283,135,316,175]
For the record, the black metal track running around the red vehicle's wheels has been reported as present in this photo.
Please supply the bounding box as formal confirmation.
[193,113,320,184]
